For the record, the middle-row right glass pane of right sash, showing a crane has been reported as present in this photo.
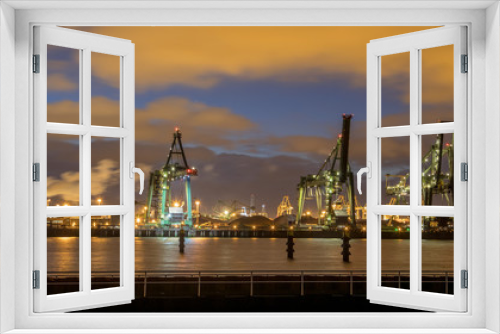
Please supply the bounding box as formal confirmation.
[421,133,454,206]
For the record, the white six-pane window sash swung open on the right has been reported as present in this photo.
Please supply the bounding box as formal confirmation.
[367,26,471,312]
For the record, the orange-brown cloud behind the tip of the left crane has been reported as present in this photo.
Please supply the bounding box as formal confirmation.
[48,96,257,148]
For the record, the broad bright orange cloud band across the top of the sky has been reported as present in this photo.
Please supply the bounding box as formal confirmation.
[67,27,449,99]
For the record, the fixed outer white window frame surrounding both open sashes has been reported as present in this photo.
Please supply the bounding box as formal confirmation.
[0,0,500,333]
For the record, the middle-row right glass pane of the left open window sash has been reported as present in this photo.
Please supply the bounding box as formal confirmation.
[91,137,121,205]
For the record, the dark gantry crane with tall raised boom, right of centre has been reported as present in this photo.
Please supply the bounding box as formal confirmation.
[296,114,356,226]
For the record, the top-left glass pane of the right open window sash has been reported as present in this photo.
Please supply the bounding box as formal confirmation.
[381,52,410,126]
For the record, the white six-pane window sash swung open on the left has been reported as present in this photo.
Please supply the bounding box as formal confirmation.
[33,26,135,312]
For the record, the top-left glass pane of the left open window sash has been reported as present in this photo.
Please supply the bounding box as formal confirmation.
[47,45,80,124]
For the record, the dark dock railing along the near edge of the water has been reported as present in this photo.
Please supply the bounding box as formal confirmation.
[48,270,453,298]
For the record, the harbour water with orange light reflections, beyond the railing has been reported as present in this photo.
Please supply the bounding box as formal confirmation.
[47,237,453,271]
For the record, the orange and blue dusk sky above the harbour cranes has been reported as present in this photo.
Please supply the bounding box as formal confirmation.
[48,27,453,217]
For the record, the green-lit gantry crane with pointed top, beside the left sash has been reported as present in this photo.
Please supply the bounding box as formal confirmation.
[145,127,198,226]
